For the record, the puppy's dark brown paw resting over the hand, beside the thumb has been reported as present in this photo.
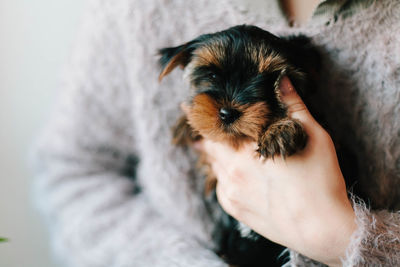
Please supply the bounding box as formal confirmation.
[257,119,308,158]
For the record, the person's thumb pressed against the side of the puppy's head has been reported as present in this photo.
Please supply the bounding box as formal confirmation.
[279,76,315,123]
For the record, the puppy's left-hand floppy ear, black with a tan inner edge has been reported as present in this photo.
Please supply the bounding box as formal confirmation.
[158,41,195,81]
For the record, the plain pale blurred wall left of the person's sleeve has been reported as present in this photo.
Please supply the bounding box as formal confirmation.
[0,0,85,267]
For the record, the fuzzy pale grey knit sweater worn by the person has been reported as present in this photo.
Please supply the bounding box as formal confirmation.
[34,0,400,267]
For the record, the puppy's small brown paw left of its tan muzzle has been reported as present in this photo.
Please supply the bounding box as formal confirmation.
[172,115,201,146]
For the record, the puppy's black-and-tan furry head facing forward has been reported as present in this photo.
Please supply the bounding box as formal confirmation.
[160,26,303,147]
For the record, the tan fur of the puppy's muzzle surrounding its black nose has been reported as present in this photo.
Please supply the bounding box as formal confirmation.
[187,94,269,148]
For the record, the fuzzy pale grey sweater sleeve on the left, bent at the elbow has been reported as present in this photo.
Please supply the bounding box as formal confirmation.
[31,1,226,267]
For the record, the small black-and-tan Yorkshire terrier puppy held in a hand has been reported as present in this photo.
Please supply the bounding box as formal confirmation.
[159,25,318,266]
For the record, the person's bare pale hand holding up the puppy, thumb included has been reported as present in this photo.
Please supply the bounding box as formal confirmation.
[197,77,356,266]
